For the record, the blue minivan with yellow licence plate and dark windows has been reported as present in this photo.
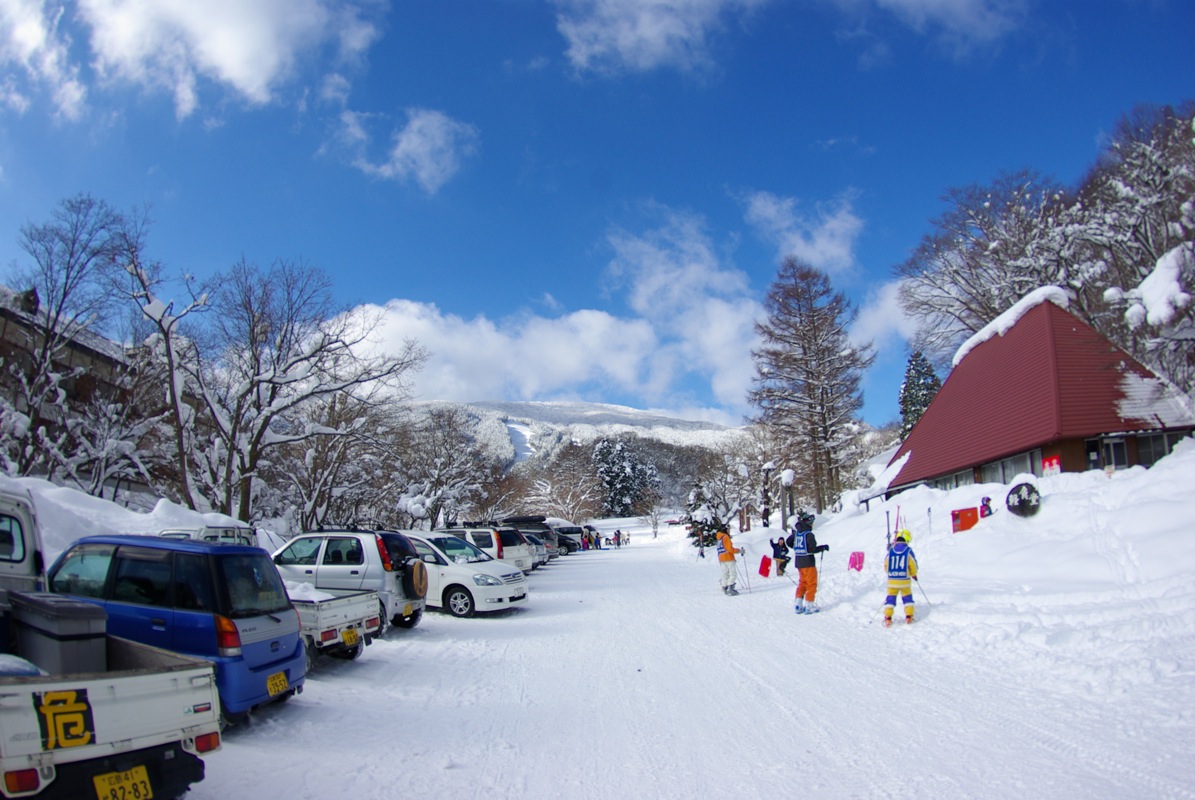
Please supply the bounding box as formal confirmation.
[48,536,305,721]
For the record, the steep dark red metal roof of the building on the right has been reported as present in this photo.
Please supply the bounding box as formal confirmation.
[888,303,1162,488]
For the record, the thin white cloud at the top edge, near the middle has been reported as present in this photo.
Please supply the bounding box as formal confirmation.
[556,0,767,72]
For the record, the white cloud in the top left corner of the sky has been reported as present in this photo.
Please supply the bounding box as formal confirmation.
[0,0,87,120]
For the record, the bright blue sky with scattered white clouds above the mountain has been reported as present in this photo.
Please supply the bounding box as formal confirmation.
[0,0,1195,425]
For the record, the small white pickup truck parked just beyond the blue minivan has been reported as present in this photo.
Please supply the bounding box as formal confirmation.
[286,581,382,673]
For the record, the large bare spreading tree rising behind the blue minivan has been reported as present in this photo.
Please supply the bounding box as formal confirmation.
[128,255,425,521]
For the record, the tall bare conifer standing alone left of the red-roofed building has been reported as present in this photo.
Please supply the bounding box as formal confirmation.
[748,258,875,512]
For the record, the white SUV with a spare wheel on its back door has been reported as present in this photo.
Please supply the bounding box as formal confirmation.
[274,531,428,628]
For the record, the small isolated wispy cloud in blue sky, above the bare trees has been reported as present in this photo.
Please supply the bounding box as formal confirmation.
[341,109,480,195]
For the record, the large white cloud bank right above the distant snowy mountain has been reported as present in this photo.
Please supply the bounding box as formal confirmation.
[353,204,760,425]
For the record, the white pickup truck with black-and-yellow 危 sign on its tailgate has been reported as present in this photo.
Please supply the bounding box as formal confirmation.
[0,491,220,800]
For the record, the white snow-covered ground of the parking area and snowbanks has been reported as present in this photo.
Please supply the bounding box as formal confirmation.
[9,440,1195,800]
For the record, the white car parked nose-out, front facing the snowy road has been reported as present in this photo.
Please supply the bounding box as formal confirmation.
[407,532,527,617]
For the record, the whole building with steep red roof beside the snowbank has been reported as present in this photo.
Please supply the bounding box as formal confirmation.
[888,287,1195,493]
